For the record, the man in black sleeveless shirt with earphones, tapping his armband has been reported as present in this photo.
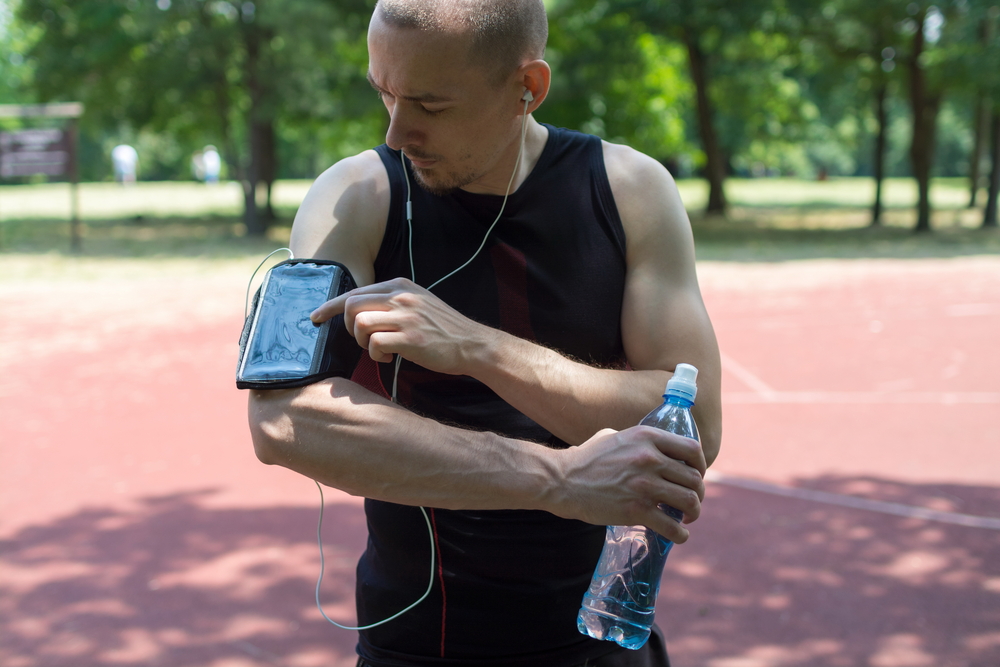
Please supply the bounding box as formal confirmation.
[250,0,721,667]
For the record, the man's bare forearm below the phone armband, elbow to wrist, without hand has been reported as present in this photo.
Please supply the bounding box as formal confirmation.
[250,378,552,509]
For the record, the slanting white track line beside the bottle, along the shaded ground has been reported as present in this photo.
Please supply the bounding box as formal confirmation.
[705,470,1000,530]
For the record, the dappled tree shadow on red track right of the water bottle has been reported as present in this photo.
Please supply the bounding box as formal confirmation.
[658,477,1000,667]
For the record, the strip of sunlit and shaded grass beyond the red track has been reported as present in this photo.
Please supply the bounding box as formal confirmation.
[0,178,1000,266]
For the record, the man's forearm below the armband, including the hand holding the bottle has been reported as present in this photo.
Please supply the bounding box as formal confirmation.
[250,378,705,542]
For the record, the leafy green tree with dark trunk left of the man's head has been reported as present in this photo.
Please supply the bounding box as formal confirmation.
[18,0,375,235]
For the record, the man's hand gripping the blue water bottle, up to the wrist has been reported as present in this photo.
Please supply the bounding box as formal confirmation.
[550,426,706,544]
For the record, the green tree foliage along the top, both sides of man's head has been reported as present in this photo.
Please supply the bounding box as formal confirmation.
[7,0,1000,233]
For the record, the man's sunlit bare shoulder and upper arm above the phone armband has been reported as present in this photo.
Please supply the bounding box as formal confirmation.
[290,151,389,285]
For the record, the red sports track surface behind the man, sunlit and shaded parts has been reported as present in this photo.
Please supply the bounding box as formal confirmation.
[0,257,1000,667]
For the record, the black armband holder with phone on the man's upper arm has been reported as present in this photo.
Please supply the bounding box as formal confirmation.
[236,259,361,389]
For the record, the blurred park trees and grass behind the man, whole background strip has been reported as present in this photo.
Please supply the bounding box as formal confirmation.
[0,0,1000,244]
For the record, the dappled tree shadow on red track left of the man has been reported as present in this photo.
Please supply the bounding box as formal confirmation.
[0,492,365,667]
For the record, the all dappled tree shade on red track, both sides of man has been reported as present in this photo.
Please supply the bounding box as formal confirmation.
[0,477,1000,667]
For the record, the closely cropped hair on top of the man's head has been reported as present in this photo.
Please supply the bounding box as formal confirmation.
[375,0,549,85]
